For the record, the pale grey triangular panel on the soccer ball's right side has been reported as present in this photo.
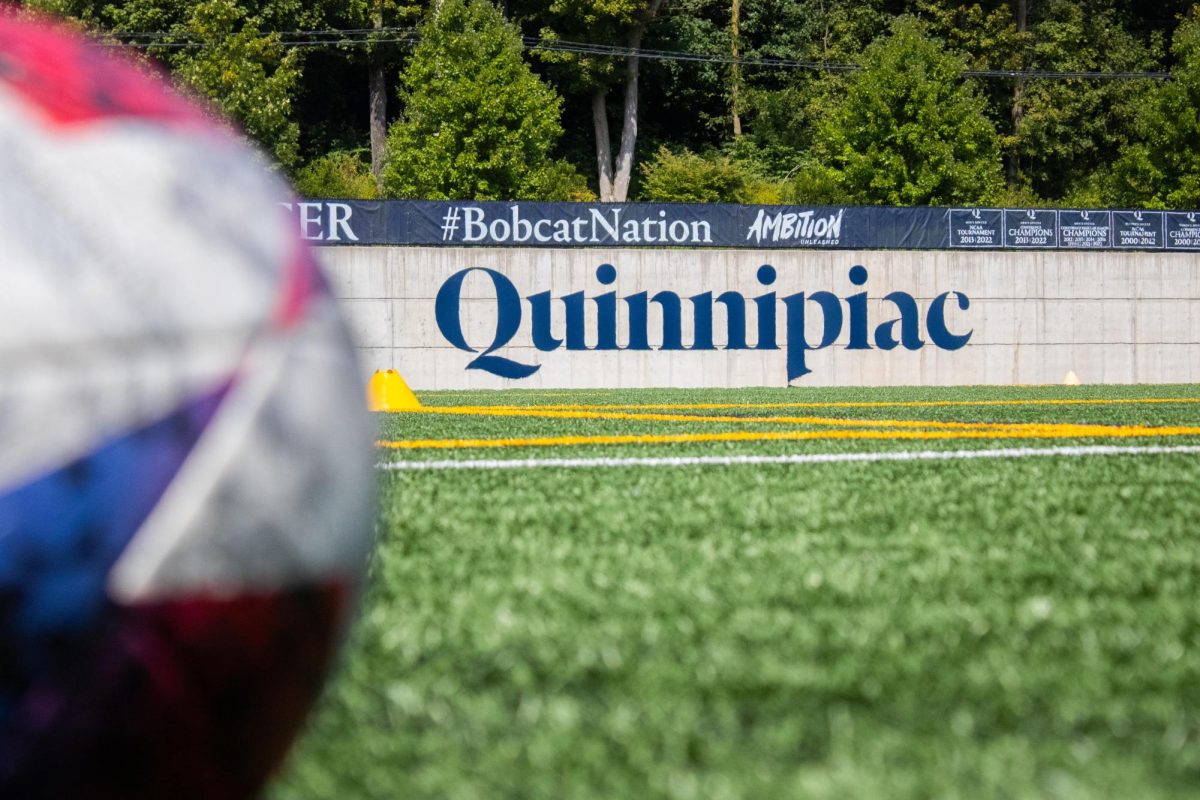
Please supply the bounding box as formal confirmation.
[112,291,373,602]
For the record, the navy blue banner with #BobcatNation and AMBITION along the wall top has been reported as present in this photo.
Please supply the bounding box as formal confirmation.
[288,200,1200,251]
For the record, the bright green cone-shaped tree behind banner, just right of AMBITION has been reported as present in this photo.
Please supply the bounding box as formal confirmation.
[794,18,1003,205]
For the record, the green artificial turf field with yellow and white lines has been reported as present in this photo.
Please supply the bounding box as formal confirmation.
[271,386,1200,800]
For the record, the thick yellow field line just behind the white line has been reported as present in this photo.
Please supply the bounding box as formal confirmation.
[376,425,1200,450]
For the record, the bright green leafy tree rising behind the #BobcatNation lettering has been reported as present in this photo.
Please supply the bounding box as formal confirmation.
[383,0,582,200]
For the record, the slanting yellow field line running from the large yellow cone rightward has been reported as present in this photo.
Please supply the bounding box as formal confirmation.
[412,405,1030,431]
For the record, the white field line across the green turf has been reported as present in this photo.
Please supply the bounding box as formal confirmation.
[378,445,1200,471]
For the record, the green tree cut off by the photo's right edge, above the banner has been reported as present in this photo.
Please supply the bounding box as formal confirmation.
[1103,11,1200,209]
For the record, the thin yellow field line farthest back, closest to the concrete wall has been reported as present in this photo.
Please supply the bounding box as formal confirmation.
[425,397,1200,411]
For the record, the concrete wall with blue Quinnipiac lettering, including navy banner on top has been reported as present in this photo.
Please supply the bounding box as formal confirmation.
[302,200,1200,389]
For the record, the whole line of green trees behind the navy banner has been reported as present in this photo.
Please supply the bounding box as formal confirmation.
[25,0,1200,206]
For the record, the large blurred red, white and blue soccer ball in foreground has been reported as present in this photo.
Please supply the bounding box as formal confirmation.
[0,12,373,800]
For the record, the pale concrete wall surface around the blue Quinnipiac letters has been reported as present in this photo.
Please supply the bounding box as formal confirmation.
[320,247,1200,390]
